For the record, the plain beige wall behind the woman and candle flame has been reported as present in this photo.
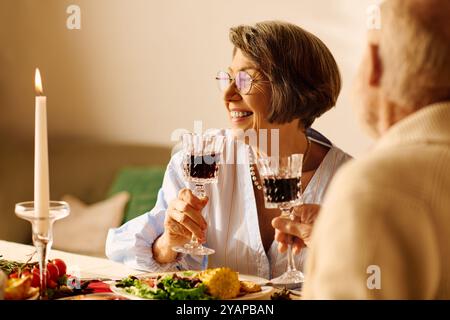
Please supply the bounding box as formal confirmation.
[0,0,373,155]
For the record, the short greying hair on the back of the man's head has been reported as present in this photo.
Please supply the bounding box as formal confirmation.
[380,0,450,109]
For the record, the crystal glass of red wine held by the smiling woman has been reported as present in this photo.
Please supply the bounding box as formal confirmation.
[172,133,225,256]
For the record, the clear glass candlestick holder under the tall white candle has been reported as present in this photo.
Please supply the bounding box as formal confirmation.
[15,201,70,300]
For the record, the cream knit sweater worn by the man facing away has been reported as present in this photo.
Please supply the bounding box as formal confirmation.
[304,102,450,299]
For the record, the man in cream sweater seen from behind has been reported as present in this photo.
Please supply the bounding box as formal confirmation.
[298,0,450,299]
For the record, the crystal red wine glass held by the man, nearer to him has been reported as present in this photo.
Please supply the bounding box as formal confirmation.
[257,154,305,287]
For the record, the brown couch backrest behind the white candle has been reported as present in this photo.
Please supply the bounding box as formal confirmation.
[0,139,171,243]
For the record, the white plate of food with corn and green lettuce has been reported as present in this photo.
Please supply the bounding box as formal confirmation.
[110,268,273,300]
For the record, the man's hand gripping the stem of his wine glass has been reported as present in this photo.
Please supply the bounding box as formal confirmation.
[272,204,320,254]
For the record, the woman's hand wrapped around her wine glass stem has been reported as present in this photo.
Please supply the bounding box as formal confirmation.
[153,188,208,263]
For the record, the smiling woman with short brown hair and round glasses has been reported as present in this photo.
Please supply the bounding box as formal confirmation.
[106,21,349,279]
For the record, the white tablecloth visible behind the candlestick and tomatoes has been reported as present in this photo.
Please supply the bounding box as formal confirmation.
[0,240,143,279]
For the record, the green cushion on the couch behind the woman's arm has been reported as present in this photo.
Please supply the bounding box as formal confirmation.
[107,166,166,223]
